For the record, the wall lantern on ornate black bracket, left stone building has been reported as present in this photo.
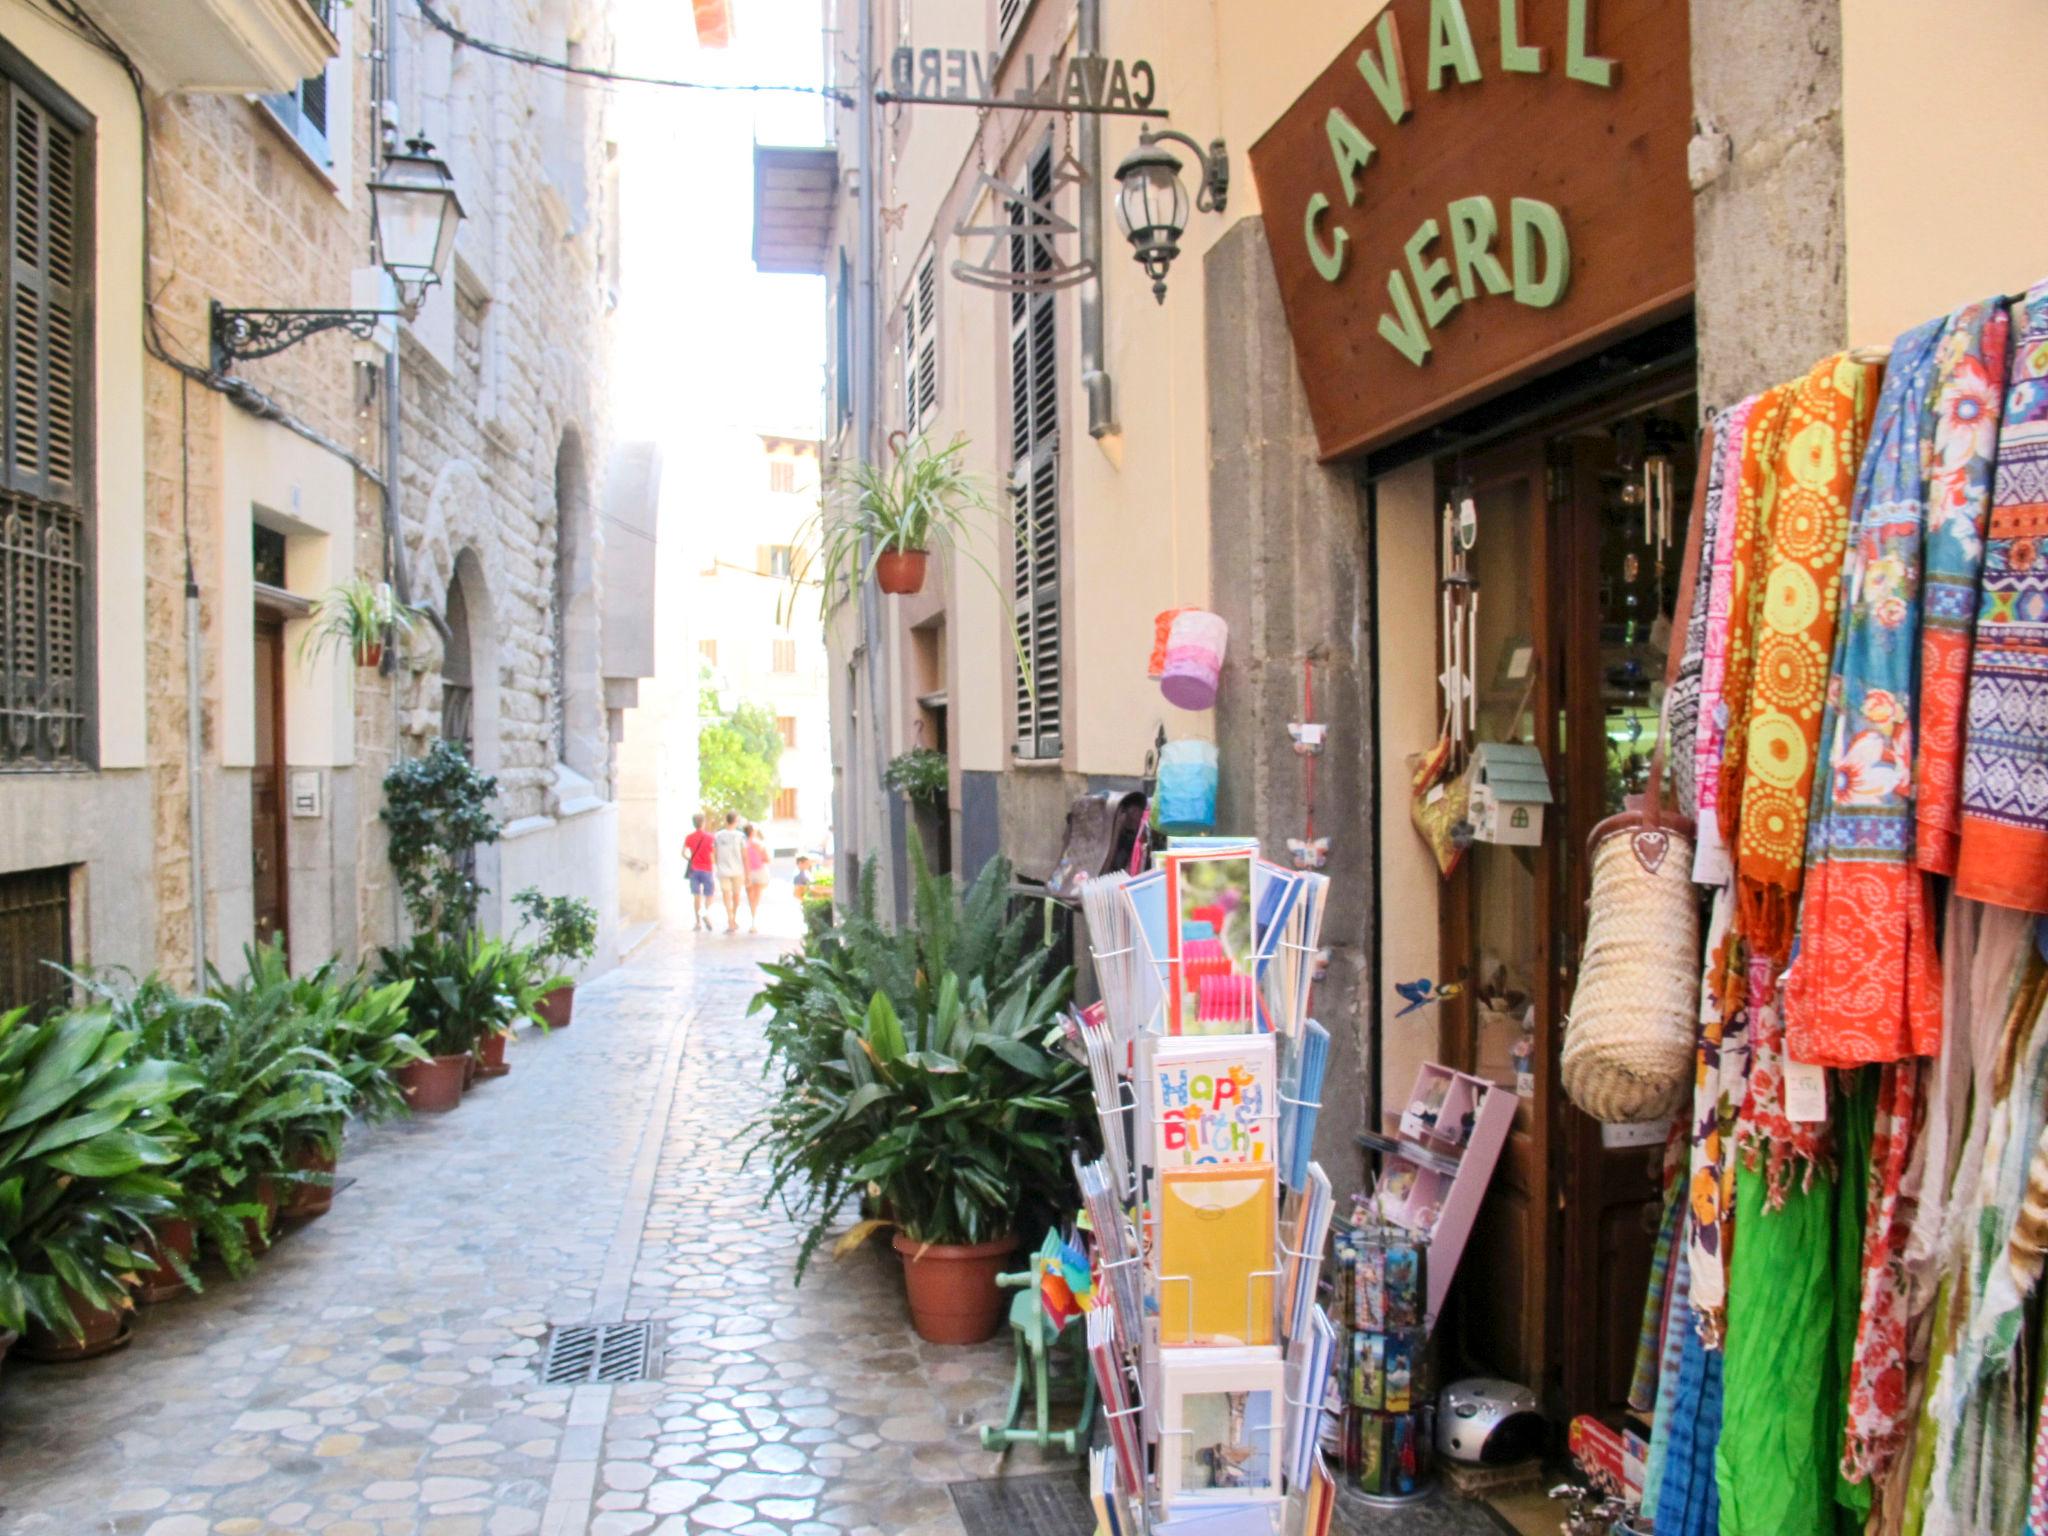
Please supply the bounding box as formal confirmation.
[213,137,463,373]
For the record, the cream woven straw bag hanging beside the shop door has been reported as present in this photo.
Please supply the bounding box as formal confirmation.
[1563,793,1700,1124]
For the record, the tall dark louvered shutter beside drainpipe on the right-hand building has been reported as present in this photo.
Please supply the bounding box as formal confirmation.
[1010,143,1065,758]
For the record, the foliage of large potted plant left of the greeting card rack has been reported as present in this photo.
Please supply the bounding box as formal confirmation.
[748,844,1085,1280]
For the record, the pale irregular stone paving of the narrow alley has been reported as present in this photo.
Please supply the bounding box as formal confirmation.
[0,913,1057,1536]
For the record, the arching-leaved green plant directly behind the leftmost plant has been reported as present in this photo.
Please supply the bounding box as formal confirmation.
[71,973,350,1276]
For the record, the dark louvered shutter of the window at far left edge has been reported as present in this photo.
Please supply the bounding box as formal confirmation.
[0,78,92,772]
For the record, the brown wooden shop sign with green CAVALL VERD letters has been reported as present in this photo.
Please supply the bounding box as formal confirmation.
[1251,0,1692,459]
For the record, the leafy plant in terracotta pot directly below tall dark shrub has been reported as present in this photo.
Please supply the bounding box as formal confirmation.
[377,932,528,1114]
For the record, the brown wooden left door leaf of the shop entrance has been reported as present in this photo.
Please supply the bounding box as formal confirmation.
[1433,438,1561,1384]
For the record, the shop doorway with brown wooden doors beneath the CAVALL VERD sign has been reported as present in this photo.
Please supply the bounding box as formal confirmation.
[1436,367,1698,1423]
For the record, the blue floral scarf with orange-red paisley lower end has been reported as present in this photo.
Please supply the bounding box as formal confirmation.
[1786,319,1946,1067]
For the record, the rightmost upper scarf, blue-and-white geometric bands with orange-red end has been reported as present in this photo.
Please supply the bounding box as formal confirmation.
[1956,285,2048,911]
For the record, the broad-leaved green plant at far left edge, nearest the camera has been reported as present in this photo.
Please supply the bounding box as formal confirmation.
[0,1004,197,1339]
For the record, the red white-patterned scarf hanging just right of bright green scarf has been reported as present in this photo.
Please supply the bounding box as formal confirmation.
[1841,1061,1923,1483]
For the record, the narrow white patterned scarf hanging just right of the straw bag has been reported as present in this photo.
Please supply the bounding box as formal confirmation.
[1686,887,1749,1350]
